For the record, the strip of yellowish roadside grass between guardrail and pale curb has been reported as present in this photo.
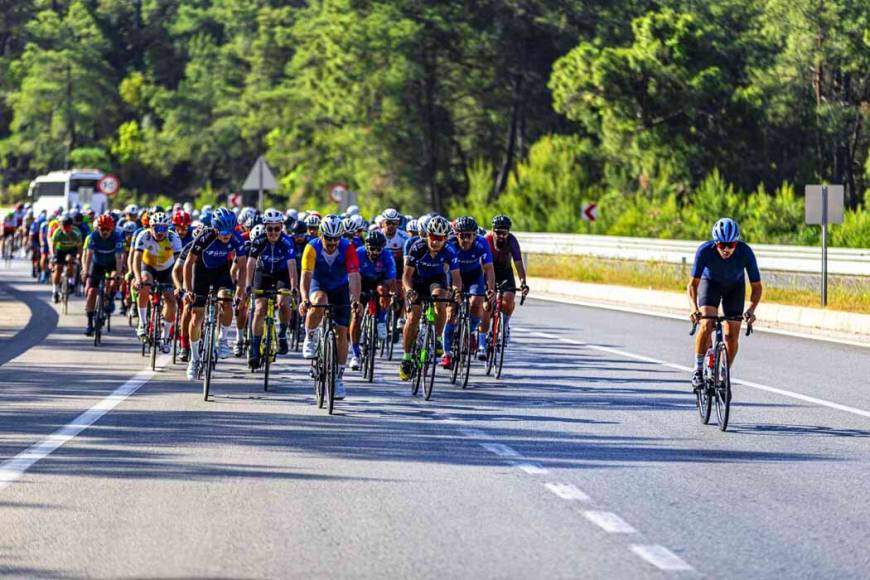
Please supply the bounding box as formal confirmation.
[527,254,870,314]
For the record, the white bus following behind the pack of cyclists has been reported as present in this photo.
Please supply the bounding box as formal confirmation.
[27,169,109,215]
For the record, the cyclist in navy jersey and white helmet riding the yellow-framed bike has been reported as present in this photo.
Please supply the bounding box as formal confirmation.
[246,209,299,368]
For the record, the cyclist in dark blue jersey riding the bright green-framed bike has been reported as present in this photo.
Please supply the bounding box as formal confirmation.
[399,216,462,381]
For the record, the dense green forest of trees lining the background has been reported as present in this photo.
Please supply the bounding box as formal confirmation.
[0,0,870,242]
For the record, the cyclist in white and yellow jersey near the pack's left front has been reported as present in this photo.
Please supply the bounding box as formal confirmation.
[133,211,181,352]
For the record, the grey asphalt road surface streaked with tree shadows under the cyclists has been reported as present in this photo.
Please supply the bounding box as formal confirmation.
[0,260,870,579]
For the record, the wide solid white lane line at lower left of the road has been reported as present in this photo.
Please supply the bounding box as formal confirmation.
[0,355,169,491]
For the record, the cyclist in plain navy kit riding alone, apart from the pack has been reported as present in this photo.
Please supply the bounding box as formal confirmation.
[687,218,762,389]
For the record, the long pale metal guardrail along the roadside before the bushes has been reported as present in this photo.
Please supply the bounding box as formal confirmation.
[514,232,870,276]
